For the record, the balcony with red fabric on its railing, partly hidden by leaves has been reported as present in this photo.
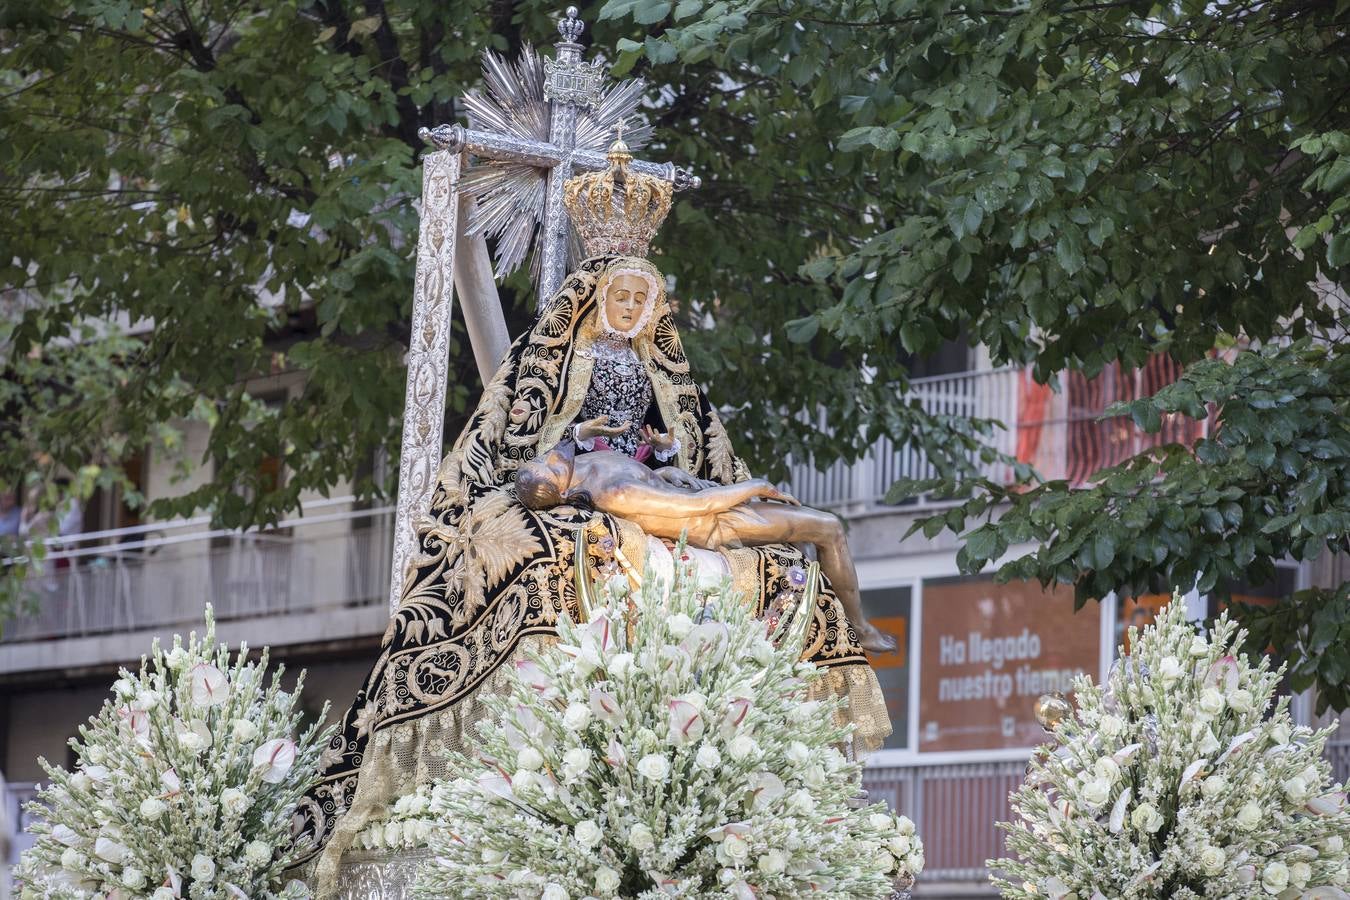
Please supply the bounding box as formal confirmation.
[787,356,1211,517]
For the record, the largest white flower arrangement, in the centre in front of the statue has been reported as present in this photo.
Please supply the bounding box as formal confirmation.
[414,558,923,900]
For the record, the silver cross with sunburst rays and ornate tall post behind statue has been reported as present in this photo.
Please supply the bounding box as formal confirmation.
[389,7,699,610]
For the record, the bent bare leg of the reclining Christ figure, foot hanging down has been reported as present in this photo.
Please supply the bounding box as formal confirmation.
[730,503,895,653]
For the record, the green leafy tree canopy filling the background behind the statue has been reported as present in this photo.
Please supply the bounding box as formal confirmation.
[0,0,1350,704]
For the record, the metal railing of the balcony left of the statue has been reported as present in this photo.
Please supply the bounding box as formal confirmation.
[0,498,393,644]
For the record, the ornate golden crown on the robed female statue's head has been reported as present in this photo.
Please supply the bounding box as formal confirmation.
[563,132,674,256]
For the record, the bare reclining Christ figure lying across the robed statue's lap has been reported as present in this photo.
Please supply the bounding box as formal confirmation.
[516,441,895,653]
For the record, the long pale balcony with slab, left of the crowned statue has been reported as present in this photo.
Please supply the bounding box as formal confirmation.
[0,498,393,673]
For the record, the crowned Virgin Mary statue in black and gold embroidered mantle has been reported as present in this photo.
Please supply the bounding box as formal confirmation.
[290,135,891,896]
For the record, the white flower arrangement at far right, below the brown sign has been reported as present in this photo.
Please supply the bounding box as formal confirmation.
[990,599,1350,900]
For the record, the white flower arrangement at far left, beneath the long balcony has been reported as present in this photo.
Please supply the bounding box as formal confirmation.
[16,606,331,900]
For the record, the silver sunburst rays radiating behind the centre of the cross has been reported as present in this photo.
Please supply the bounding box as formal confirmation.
[463,46,652,285]
